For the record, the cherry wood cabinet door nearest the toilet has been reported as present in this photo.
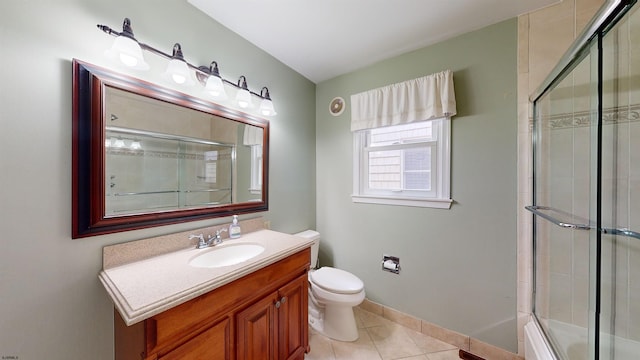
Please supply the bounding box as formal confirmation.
[277,274,309,360]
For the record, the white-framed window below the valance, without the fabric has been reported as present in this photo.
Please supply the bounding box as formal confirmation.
[352,117,451,209]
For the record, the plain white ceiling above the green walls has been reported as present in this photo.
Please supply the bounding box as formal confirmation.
[187,0,560,83]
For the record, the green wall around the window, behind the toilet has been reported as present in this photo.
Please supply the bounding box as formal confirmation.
[316,19,517,352]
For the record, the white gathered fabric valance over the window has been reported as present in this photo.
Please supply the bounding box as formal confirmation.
[351,70,456,131]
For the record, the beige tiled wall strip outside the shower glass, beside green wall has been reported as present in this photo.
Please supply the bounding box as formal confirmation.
[518,0,604,354]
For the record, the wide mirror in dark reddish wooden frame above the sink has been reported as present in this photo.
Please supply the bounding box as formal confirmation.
[72,59,269,238]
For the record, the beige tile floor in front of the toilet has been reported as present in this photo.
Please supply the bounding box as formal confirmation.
[305,307,460,360]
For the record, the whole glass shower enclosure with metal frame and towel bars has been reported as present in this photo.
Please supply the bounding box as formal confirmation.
[527,1,640,360]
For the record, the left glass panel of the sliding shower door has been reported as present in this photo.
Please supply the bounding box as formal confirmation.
[534,43,597,360]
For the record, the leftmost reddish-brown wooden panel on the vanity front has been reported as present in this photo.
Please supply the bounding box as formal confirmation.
[158,318,231,360]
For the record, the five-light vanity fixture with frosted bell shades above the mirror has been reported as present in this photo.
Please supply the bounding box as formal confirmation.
[98,18,276,116]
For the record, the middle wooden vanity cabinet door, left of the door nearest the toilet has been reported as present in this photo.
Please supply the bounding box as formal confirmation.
[236,293,277,360]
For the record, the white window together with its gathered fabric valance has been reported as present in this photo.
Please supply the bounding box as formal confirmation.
[351,70,456,209]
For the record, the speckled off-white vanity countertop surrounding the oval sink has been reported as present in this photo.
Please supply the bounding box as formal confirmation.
[98,230,312,325]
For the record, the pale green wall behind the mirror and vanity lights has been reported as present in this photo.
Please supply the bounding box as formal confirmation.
[0,0,315,360]
